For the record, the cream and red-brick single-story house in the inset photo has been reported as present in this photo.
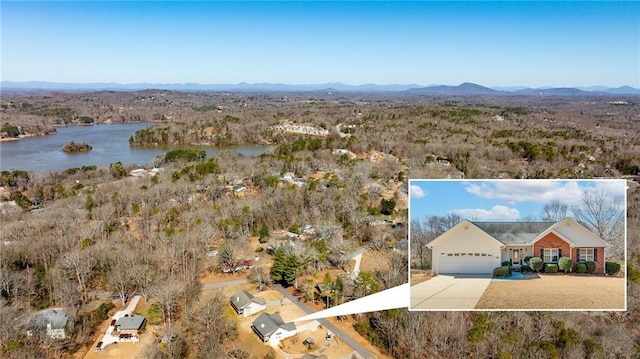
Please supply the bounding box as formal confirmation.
[427,218,609,274]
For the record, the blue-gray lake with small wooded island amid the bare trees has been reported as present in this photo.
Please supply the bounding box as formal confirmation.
[0,123,265,172]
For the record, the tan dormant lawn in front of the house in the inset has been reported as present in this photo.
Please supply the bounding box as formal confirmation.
[476,274,626,310]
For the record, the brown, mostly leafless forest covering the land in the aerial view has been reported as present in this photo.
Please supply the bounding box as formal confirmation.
[0,90,640,359]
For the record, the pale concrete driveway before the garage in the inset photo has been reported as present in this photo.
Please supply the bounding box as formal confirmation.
[410,274,491,310]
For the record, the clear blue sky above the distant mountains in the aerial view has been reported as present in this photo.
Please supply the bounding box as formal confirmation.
[1,1,640,87]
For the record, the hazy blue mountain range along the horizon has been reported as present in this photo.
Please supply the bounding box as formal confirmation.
[0,81,640,96]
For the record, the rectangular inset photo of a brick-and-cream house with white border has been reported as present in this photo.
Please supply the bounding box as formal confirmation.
[409,180,626,311]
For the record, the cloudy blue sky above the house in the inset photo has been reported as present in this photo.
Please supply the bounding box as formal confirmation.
[409,180,626,222]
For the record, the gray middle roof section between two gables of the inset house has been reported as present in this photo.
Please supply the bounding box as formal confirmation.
[471,222,555,245]
